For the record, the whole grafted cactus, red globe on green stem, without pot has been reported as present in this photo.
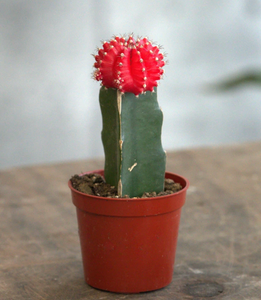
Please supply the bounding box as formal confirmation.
[94,36,165,197]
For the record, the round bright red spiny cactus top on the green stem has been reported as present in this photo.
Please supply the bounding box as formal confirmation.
[94,35,165,95]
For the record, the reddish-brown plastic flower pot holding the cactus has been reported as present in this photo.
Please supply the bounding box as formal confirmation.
[69,170,189,293]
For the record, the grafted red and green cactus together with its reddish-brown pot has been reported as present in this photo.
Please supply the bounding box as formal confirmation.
[69,36,188,293]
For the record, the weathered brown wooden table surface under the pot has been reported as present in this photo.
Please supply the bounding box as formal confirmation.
[0,142,261,300]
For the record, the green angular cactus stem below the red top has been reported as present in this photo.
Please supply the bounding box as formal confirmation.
[99,87,166,197]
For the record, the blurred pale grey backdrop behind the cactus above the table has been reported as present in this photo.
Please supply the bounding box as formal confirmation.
[0,0,261,169]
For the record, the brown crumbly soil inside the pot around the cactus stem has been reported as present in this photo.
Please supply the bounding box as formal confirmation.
[71,173,182,198]
